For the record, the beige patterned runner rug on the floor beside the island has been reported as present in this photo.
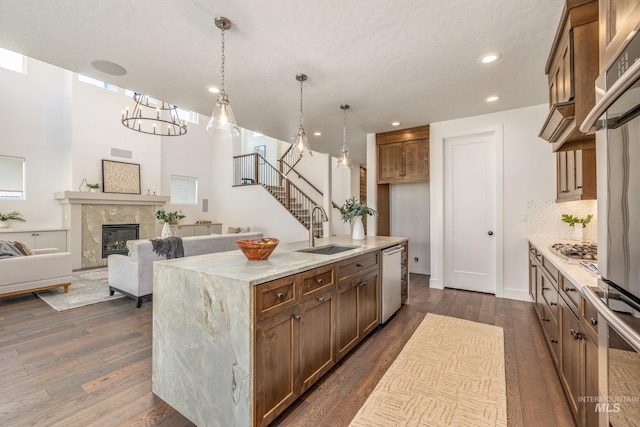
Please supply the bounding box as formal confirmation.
[350,314,507,427]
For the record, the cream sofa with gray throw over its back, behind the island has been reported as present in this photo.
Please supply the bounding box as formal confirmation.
[107,232,262,308]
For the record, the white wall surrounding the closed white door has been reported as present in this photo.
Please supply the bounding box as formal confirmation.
[430,104,556,300]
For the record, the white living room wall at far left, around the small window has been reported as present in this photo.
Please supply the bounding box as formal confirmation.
[0,60,72,230]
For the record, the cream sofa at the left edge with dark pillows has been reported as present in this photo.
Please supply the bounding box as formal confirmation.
[0,248,71,297]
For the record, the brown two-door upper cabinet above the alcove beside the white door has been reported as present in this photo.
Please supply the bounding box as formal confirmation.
[376,125,429,184]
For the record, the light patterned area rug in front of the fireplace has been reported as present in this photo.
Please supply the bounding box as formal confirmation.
[37,267,124,311]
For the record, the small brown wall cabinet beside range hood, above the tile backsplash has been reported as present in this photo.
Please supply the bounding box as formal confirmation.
[556,148,597,202]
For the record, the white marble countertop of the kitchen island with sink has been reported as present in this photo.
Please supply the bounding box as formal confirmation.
[156,236,408,285]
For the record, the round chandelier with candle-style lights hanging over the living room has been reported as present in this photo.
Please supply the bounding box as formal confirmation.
[122,92,187,136]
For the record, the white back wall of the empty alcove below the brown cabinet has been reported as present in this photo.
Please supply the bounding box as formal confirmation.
[389,182,431,274]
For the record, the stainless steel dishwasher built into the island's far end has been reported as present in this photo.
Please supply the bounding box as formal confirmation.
[380,245,404,323]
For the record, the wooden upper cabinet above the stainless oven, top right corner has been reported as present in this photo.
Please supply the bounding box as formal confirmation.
[600,0,640,72]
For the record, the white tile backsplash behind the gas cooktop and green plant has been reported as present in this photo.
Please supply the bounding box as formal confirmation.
[527,200,598,242]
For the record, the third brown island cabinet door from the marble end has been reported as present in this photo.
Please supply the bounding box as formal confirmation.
[336,280,360,360]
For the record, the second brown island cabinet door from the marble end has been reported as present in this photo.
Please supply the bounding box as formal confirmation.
[300,289,336,393]
